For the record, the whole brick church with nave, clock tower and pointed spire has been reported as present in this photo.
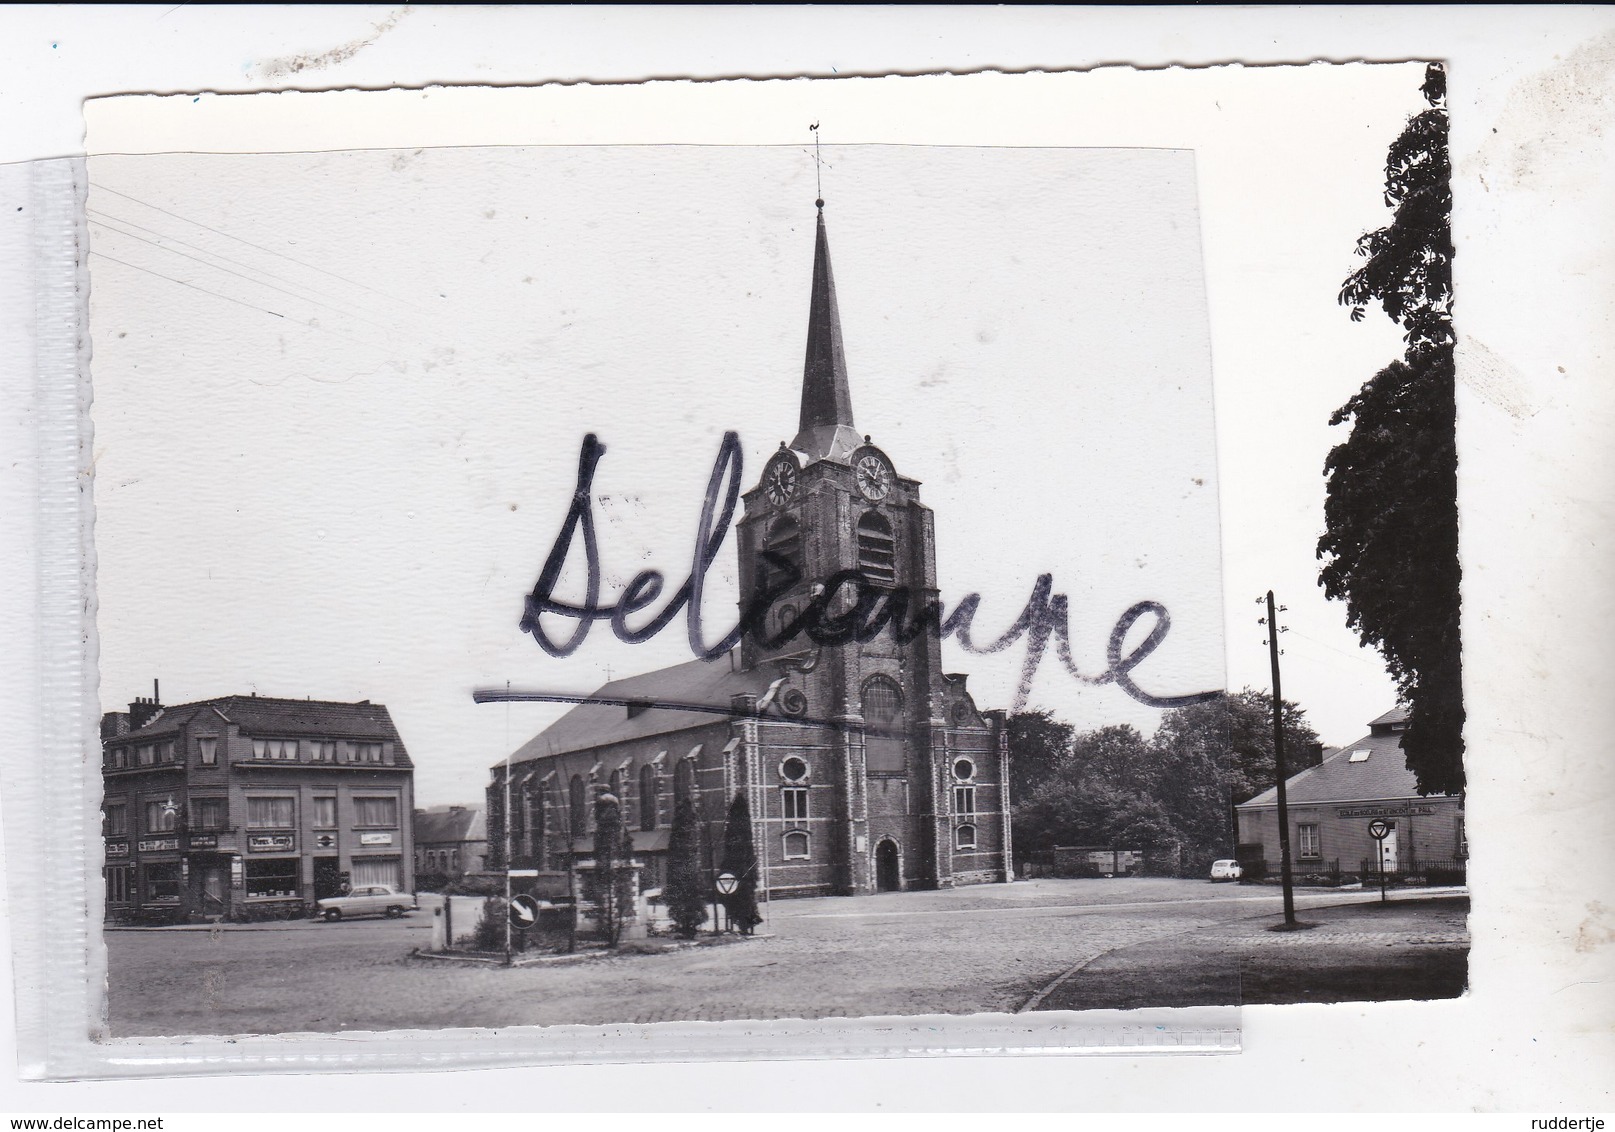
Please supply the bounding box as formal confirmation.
[488,200,1013,896]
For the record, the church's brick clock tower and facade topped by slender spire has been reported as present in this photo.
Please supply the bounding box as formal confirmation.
[738,200,1000,891]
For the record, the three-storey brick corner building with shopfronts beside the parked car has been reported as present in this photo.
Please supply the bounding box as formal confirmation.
[102,686,415,922]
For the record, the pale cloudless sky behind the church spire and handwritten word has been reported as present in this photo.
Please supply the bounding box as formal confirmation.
[89,66,1421,804]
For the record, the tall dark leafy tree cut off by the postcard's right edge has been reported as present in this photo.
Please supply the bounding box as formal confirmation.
[1318,63,1465,794]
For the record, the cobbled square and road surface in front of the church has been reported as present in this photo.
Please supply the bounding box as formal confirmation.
[97,878,1466,1037]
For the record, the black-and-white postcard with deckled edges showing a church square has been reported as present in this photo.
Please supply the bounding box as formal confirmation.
[66,63,1468,1045]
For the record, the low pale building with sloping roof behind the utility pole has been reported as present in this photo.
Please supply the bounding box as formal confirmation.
[1235,707,1468,877]
